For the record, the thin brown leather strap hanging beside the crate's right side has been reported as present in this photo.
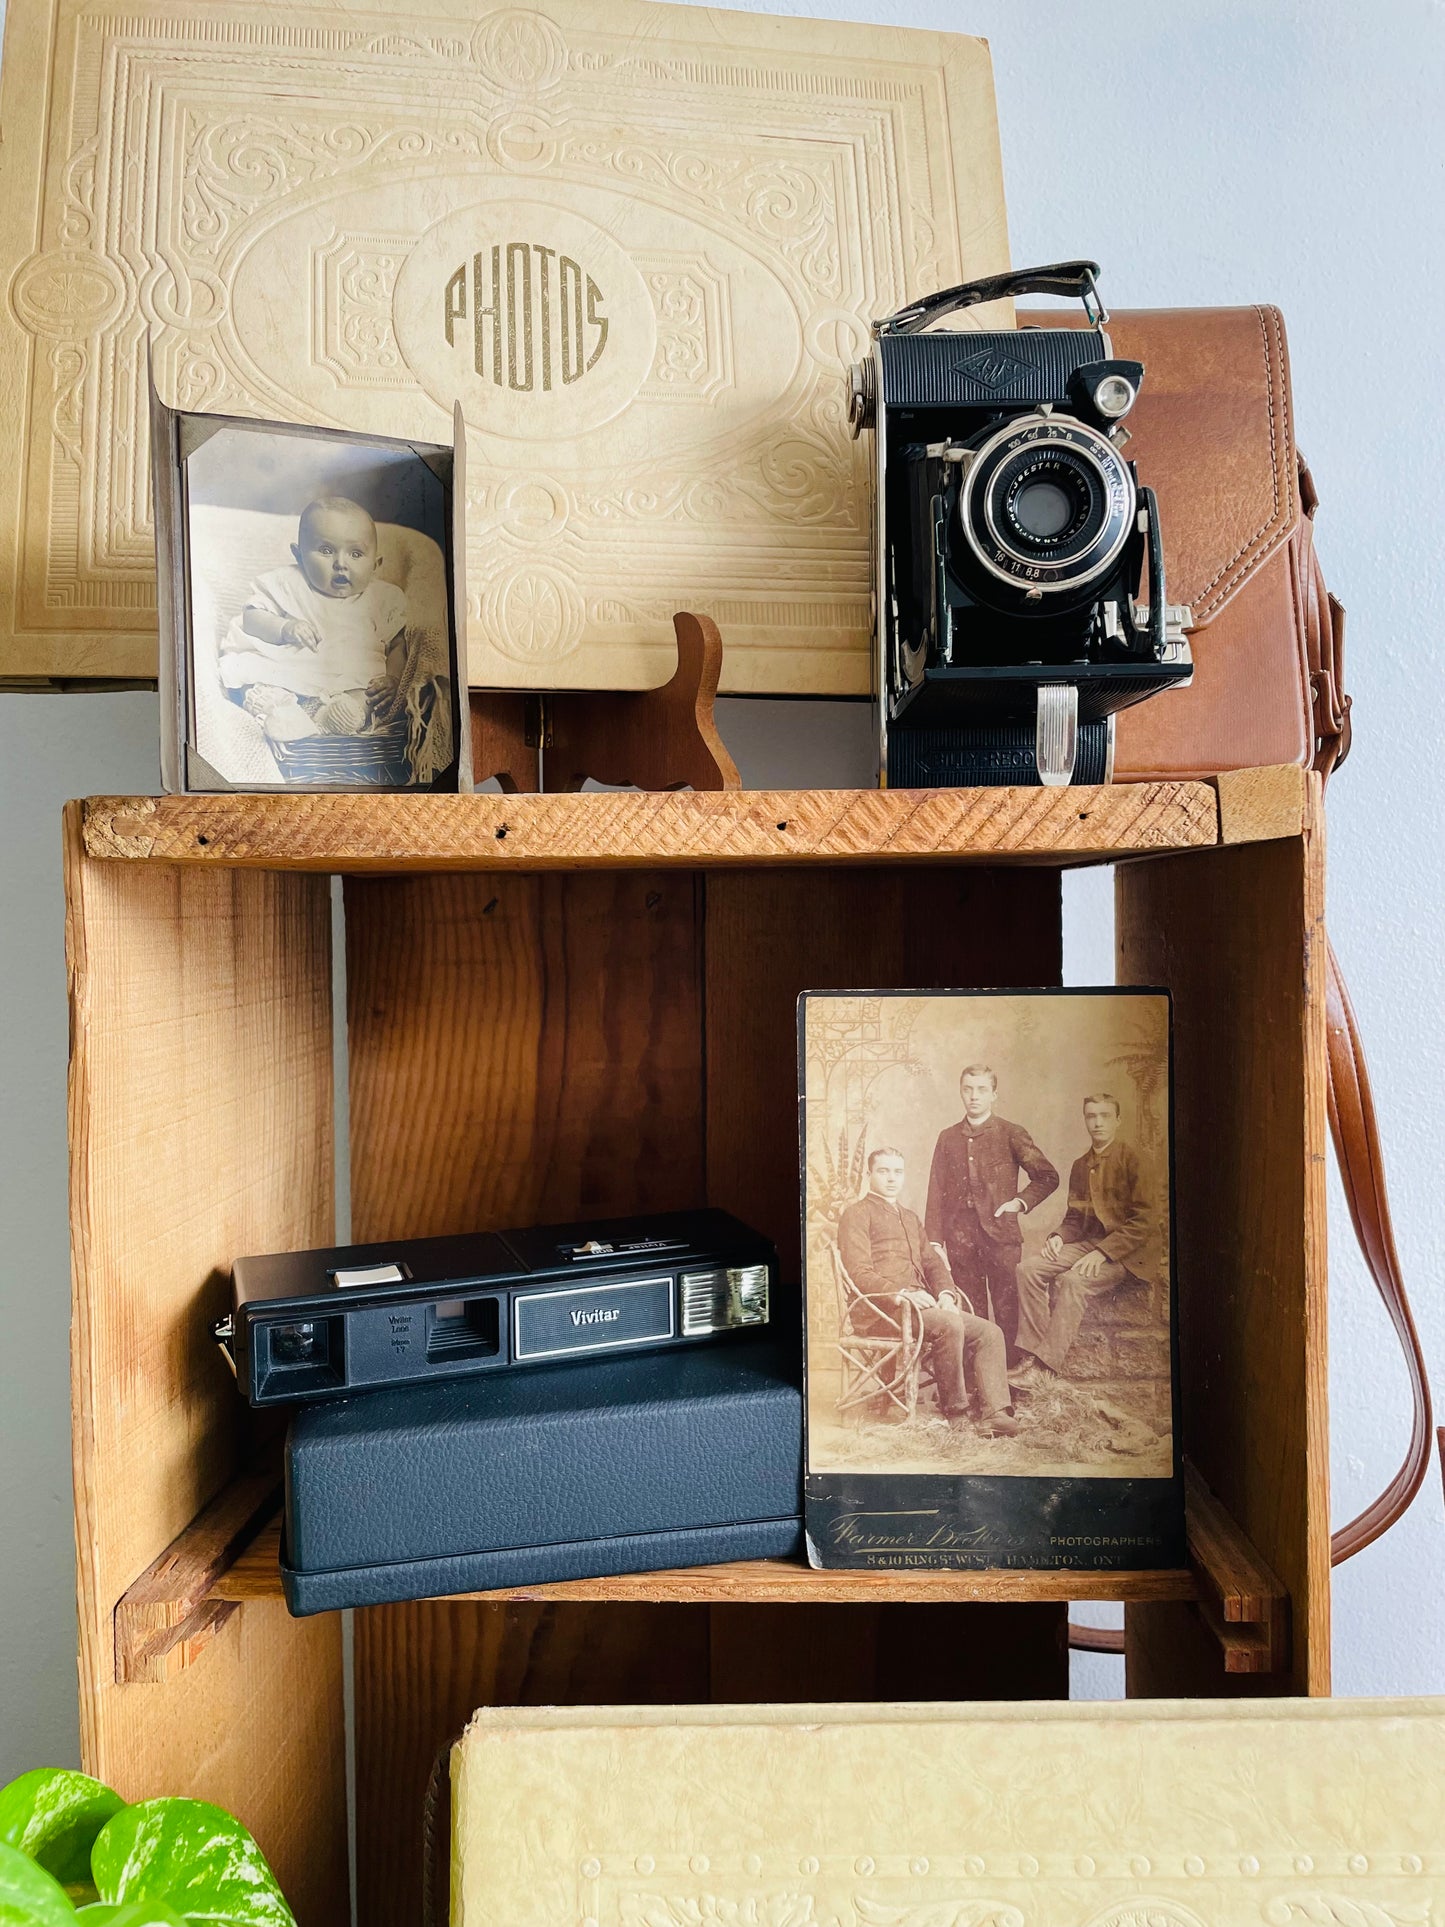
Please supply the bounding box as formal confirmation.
[1326,944,1432,1565]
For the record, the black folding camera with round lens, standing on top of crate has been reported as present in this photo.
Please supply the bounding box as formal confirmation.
[850,260,1193,788]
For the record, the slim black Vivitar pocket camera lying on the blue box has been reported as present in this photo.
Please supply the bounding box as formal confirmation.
[214,1210,776,1405]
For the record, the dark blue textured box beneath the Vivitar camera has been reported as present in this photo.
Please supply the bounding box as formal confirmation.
[281,1333,803,1615]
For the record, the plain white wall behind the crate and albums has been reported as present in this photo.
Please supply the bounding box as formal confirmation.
[0,0,1445,1781]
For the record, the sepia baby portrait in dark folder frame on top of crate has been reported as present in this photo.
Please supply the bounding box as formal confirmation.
[152,389,468,790]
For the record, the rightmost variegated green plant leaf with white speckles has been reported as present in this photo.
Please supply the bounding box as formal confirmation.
[91,1800,295,1927]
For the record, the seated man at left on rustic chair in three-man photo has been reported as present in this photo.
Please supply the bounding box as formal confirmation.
[838,1147,1019,1438]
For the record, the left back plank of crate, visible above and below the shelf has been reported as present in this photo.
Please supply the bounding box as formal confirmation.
[345,873,707,1927]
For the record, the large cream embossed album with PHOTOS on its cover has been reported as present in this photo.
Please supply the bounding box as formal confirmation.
[0,0,1008,696]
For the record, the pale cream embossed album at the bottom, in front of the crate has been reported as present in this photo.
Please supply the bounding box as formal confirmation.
[451,1703,1445,1927]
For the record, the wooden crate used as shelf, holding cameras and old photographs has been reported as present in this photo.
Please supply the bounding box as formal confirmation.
[66,769,1329,1927]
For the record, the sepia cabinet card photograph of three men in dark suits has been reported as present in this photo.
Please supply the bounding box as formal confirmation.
[800,989,1183,1569]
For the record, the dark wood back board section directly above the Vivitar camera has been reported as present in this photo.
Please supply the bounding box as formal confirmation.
[345,873,703,1241]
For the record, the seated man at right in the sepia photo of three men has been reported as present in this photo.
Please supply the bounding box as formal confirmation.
[1013,1091,1160,1380]
